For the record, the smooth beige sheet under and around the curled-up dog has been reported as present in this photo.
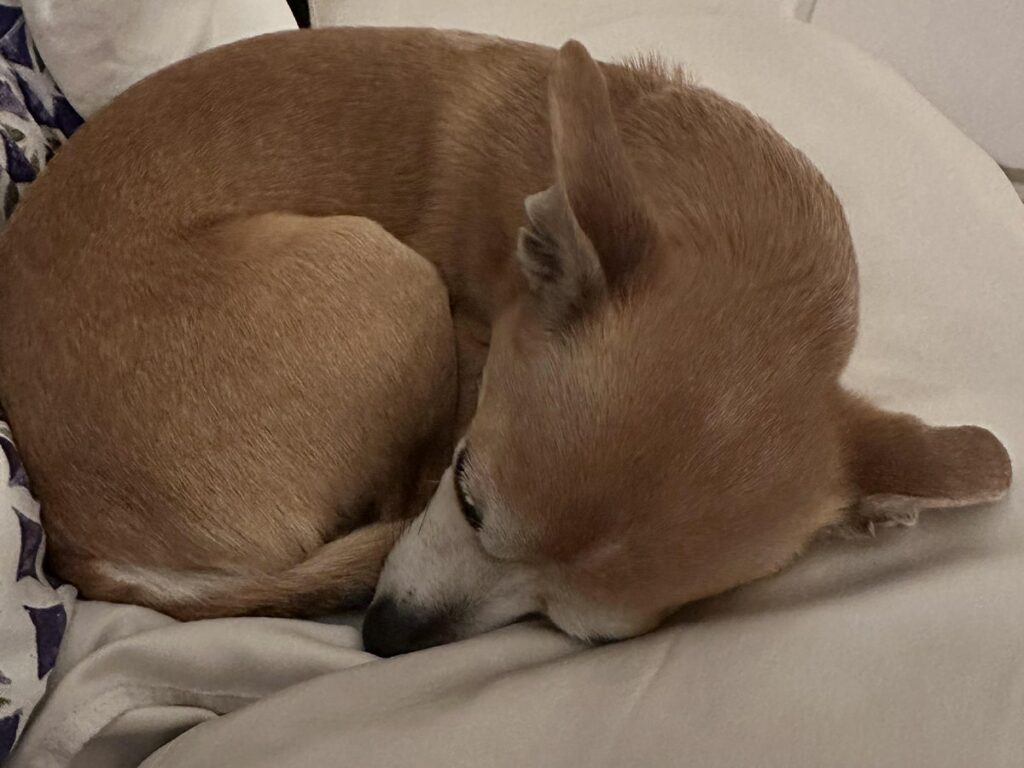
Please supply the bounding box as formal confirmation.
[11,10,1024,768]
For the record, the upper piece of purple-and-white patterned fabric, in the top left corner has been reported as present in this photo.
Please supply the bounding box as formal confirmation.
[0,0,82,222]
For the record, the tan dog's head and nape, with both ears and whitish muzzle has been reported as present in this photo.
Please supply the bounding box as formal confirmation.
[364,43,1009,655]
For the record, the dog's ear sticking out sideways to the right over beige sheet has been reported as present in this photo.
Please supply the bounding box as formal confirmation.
[840,394,1013,524]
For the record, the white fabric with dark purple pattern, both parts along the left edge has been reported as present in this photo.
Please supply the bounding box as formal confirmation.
[0,0,82,763]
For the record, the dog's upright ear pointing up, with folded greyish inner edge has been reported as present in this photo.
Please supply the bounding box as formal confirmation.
[518,41,656,327]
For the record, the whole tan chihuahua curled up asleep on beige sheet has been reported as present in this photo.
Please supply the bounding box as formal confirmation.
[0,29,1011,654]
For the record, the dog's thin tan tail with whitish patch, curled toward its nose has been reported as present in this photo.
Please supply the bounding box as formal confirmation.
[63,520,409,621]
